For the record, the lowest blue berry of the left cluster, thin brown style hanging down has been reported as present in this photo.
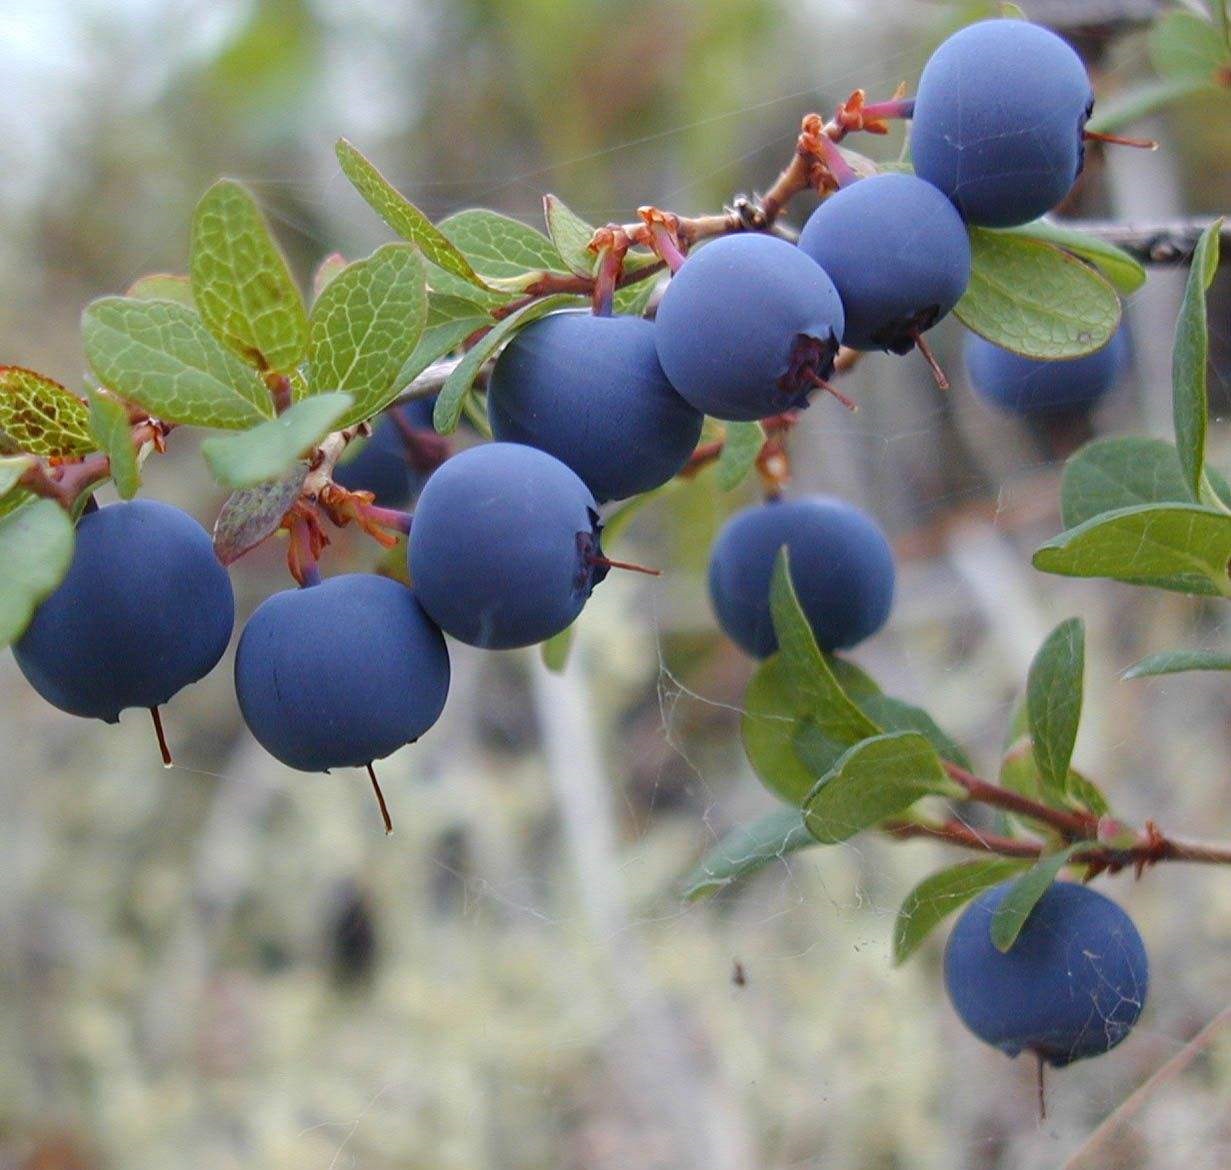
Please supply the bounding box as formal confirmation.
[235,573,449,772]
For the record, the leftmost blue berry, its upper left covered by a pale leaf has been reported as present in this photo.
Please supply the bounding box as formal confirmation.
[14,500,235,723]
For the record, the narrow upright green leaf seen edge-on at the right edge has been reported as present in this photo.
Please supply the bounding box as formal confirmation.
[1171,219,1222,504]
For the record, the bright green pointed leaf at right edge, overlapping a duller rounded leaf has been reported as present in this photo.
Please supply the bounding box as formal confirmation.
[1034,504,1231,597]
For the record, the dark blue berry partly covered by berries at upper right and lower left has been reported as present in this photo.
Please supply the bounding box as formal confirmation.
[487,312,703,502]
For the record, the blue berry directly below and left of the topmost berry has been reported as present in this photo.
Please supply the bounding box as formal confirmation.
[799,175,970,353]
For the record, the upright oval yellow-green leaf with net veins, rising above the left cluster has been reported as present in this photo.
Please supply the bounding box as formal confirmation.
[188,179,308,373]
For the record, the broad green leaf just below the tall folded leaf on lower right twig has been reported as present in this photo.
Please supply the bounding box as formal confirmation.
[804,732,963,845]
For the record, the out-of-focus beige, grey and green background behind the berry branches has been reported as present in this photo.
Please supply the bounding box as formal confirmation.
[0,0,1231,1170]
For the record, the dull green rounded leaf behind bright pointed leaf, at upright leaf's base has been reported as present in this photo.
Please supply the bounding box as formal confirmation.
[1060,435,1231,528]
